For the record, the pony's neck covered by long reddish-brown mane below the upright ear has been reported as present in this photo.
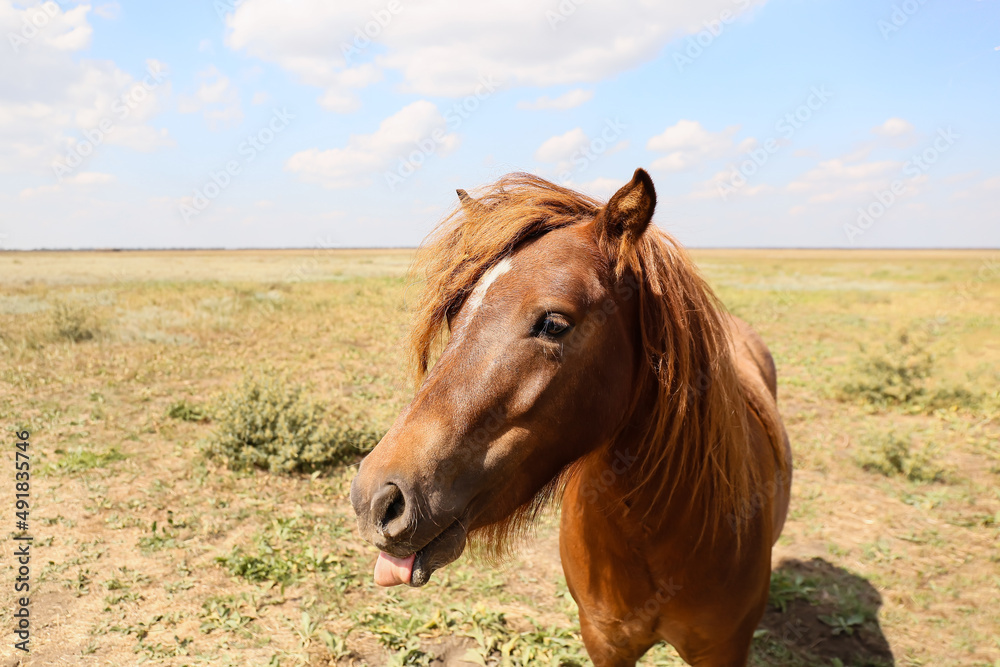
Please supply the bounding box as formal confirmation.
[583,245,758,541]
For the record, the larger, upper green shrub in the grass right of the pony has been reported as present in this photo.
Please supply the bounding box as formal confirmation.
[841,331,934,407]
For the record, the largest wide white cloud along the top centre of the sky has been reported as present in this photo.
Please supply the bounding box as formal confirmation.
[226,0,764,111]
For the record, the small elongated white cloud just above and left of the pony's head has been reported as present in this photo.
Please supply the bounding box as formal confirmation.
[285,100,459,189]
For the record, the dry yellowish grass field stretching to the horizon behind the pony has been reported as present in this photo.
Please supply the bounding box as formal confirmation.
[0,250,1000,667]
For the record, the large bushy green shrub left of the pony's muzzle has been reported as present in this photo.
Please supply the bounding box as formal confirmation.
[205,373,380,472]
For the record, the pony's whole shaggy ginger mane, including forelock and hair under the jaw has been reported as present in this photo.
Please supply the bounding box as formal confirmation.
[409,173,772,555]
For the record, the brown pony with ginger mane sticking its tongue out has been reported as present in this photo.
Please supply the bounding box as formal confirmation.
[351,169,791,667]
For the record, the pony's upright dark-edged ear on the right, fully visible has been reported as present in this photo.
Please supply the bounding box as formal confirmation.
[594,168,656,260]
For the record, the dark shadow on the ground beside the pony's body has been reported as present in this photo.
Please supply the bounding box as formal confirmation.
[751,558,895,667]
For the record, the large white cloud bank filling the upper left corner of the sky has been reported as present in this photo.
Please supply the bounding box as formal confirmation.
[0,2,171,176]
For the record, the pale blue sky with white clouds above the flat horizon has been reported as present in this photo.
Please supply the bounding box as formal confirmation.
[0,0,1000,249]
